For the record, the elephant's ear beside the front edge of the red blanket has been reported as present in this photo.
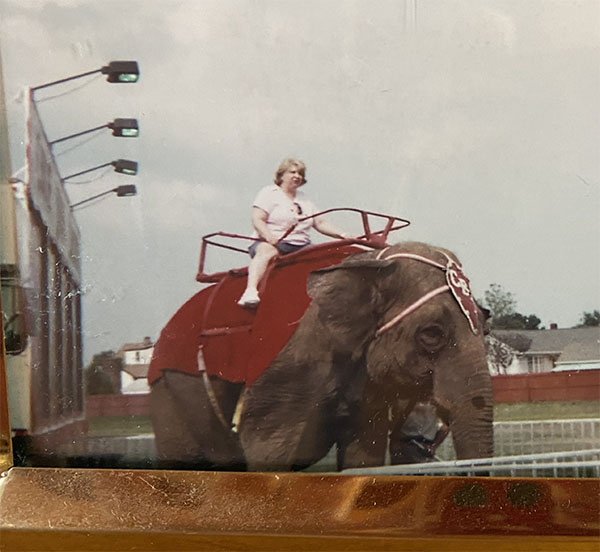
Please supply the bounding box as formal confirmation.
[307,258,395,350]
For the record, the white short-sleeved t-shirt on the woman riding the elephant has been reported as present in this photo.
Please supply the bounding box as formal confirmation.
[252,184,318,245]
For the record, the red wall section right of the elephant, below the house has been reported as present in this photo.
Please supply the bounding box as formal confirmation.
[492,370,600,403]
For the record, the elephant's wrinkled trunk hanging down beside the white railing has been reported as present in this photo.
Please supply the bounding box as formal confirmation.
[434,356,494,459]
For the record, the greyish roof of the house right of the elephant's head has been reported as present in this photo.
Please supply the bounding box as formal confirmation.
[492,326,600,361]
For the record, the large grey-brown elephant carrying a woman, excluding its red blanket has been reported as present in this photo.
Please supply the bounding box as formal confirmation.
[151,242,493,471]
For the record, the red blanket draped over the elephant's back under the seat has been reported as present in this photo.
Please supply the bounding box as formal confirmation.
[148,242,364,385]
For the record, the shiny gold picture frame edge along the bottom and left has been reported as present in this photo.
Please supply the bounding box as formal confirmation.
[0,4,600,551]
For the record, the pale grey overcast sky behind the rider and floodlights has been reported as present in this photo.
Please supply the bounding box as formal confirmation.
[0,0,600,361]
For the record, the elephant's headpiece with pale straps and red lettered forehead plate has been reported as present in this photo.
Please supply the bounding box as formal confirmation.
[375,247,479,337]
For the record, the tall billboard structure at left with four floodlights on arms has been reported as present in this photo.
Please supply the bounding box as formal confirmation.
[0,61,140,464]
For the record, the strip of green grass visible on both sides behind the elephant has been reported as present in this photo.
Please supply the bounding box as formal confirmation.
[88,401,600,437]
